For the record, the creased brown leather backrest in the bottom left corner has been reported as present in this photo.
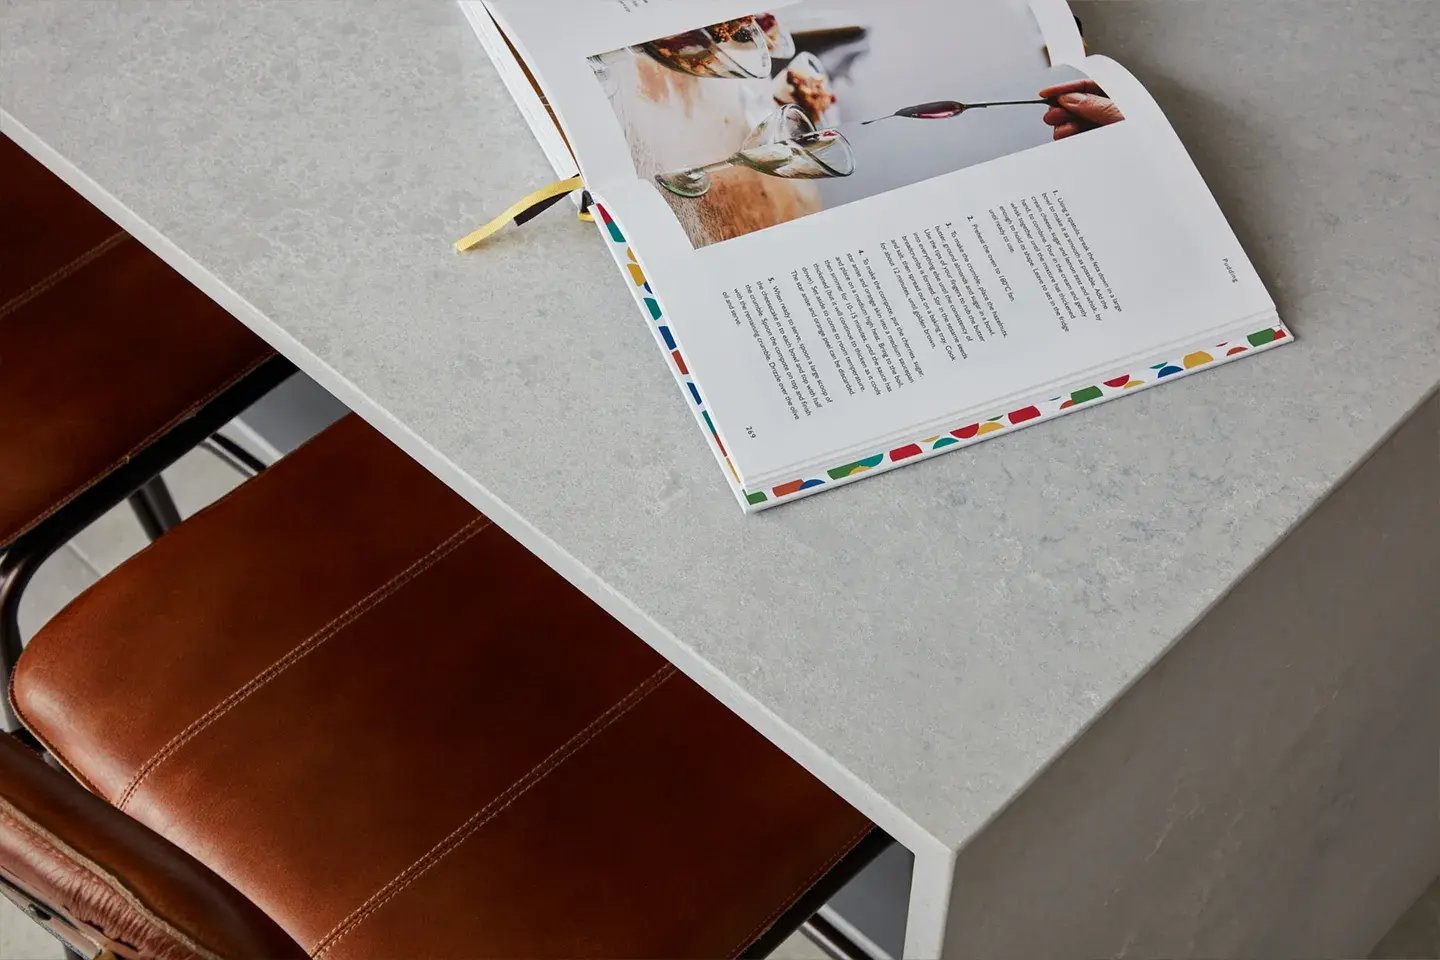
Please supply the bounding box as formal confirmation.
[0,734,305,960]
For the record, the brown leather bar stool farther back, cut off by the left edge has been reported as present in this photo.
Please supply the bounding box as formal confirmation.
[0,137,294,711]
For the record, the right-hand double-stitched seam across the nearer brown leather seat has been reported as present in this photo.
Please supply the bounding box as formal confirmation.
[310,664,675,960]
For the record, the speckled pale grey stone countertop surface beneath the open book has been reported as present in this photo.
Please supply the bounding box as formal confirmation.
[0,0,1440,855]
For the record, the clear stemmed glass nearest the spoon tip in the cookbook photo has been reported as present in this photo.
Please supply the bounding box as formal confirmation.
[655,104,855,199]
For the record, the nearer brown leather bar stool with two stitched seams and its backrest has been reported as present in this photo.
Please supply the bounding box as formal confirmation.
[0,416,887,960]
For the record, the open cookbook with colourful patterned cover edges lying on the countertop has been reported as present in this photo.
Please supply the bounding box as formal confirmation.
[461,0,1290,511]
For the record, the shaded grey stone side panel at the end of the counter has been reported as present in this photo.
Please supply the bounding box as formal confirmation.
[949,397,1440,960]
